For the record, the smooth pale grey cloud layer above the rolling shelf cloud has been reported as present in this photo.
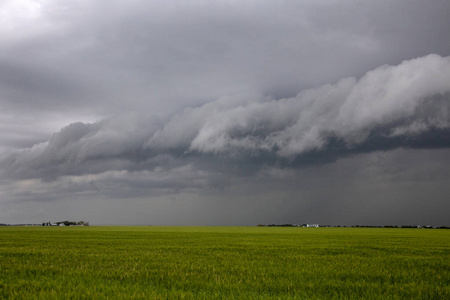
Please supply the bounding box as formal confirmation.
[0,1,450,116]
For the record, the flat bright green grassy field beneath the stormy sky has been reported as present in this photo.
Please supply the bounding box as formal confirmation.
[0,226,450,299]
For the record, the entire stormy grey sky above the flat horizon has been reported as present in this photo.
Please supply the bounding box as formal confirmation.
[0,0,450,226]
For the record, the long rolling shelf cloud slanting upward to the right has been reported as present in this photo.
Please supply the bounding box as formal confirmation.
[0,55,450,180]
